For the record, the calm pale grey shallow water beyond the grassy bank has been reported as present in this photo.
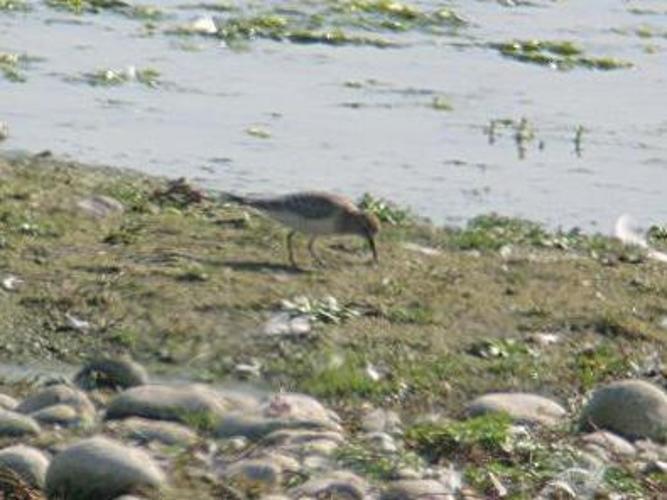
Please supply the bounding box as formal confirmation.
[0,0,667,232]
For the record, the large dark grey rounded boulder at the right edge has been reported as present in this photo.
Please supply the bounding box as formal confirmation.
[580,380,667,442]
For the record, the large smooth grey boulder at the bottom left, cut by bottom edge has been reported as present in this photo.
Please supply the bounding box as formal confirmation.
[45,437,166,500]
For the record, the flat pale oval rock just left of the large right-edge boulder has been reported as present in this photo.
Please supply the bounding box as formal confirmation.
[466,392,567,426]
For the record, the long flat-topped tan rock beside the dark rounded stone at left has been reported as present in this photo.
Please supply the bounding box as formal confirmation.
[106,385,227,424]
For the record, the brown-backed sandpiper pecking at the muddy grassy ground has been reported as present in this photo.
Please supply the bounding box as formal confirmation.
[223,191,380,267]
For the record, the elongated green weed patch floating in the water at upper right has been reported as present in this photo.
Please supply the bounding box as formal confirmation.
[491,40,632,71]
